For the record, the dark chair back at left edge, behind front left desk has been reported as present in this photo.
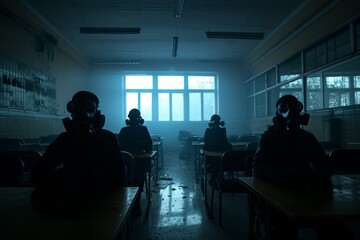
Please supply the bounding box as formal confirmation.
[0,154,24,187]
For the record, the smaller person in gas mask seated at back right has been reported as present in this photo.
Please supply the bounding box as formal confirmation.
[201,114,232,185]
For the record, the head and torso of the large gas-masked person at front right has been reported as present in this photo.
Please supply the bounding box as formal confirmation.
[253,95,332,184]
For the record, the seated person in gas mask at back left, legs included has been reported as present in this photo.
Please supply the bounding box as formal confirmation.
[118,108,152,215]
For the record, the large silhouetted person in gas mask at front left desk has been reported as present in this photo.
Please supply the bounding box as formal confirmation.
[32,91,126,192]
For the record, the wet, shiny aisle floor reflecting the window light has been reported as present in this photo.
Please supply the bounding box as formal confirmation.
[133,153,247,240]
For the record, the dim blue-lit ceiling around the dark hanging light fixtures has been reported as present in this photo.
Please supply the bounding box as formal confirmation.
[23,0,306,63]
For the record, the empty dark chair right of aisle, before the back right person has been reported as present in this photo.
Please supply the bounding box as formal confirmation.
[210,150,255,226]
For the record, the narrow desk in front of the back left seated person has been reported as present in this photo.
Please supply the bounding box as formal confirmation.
[133,151,158,209]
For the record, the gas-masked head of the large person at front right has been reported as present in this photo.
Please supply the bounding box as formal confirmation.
[274,95,309,128]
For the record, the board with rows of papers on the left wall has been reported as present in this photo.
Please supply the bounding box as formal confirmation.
[0,55,58,114]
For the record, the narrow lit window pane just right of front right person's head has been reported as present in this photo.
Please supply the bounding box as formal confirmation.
[306,77,323,110]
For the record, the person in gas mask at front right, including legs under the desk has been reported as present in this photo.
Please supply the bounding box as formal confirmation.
[253,95,352,239]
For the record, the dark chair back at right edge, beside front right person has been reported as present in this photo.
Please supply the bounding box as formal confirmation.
[329,148,360,174]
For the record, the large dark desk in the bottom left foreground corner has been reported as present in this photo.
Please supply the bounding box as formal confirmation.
[0,187,139,240]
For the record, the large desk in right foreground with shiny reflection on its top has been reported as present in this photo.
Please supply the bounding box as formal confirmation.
[240,175,360,239]
